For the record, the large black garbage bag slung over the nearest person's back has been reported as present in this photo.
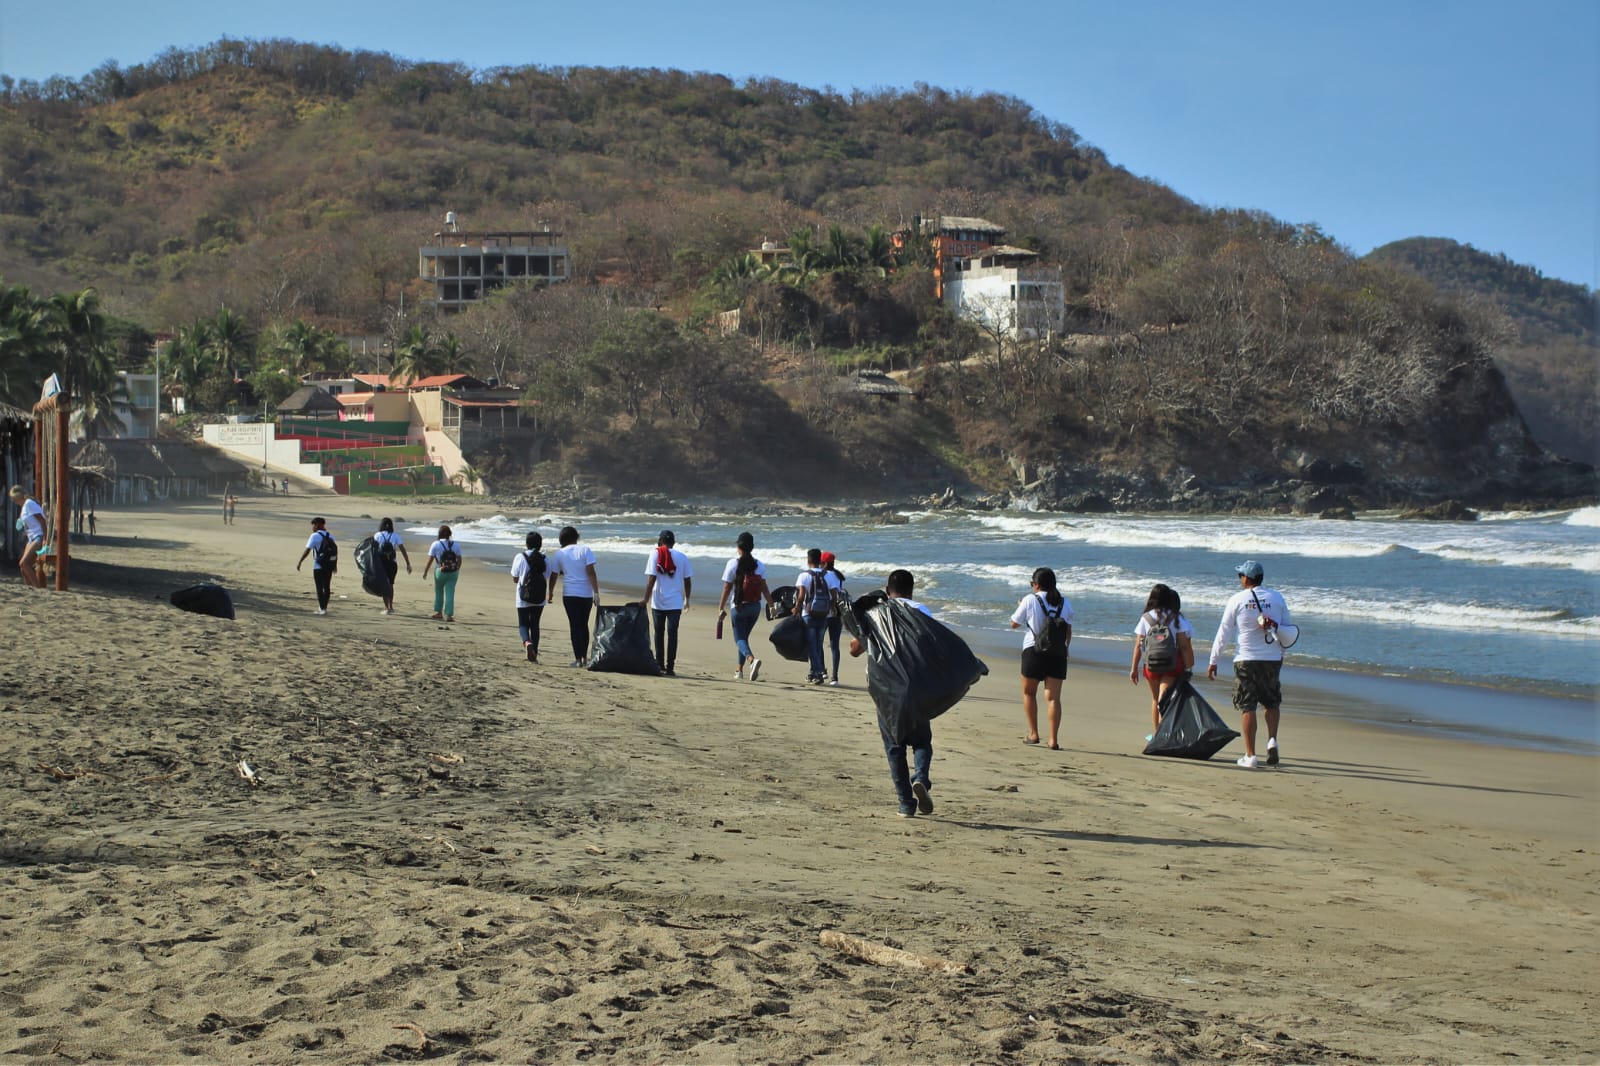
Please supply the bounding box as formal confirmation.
[843,594,989,743]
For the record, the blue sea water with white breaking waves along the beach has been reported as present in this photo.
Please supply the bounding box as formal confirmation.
[410,507,1600,752]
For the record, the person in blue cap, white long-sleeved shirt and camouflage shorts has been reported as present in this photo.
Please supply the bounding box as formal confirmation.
[1205,559,1293,770]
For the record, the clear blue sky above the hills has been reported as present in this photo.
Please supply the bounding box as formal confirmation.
[0,0,1600,288]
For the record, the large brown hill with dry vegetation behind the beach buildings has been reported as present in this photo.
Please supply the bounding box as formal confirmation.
[0,40,1592,507]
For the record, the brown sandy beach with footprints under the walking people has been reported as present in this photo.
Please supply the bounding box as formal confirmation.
[0,496,1600,1064]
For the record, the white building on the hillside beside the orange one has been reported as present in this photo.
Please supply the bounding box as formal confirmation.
[944,245,1067,338]
